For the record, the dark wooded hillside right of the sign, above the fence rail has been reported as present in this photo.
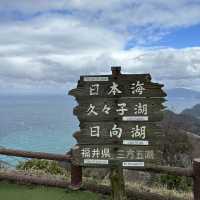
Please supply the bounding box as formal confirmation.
[160,108,200,167]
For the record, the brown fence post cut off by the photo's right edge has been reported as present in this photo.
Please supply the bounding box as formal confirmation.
[193,158,200,200]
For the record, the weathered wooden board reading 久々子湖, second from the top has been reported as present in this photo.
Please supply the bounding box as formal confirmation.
[74,98,165,121]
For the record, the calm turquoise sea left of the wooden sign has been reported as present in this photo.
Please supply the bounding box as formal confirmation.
[0,95,79,165]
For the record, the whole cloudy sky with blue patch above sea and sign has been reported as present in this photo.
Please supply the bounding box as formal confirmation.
[0,0,200,93]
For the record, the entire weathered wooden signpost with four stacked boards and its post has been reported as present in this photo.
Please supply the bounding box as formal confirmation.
[69,67,166,200]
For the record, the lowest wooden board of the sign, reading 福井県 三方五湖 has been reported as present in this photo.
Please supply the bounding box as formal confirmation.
[72,145,162,168]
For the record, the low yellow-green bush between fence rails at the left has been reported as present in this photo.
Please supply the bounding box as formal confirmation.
[16,159,66,175]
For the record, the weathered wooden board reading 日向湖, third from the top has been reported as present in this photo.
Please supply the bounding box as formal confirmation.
[74,122,163,146]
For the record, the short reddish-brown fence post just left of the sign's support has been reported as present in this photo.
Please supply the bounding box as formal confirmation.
[70,163,82,190]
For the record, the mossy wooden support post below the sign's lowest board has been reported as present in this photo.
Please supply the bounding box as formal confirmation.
[110,166,127,200]
